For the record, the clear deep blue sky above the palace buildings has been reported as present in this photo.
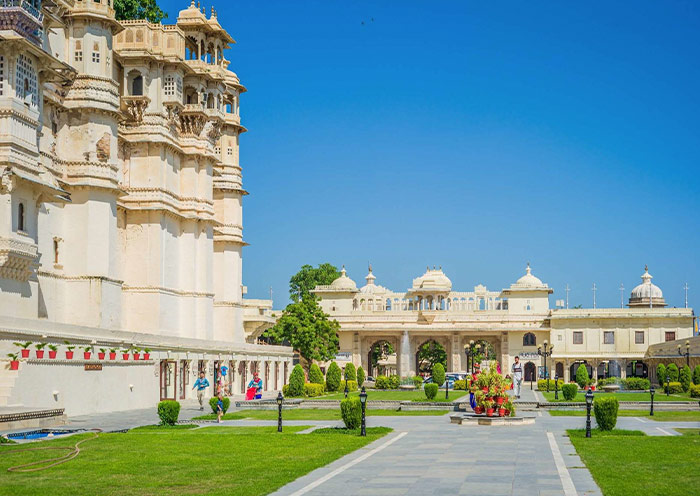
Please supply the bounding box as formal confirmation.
[162,0,700,308]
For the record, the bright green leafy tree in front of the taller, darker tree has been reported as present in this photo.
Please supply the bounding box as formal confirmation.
[263,295,340,368]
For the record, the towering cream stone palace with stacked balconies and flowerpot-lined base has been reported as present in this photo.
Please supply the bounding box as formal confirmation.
[0,0,292,414]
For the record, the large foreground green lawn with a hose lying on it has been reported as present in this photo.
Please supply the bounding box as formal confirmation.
[0,426,391,496]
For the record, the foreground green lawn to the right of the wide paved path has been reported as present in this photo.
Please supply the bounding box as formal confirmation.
[567,430,700,496]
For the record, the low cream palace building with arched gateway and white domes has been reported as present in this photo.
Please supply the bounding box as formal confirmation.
[314,264,694,381]
